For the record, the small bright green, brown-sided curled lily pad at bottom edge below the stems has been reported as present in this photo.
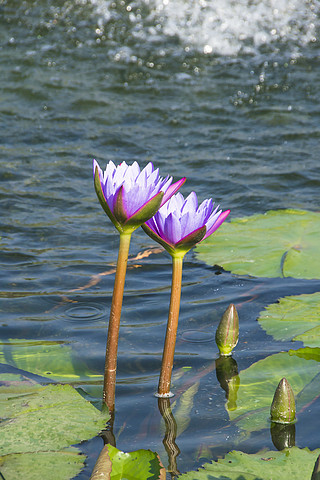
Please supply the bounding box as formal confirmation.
[91,445,166,480]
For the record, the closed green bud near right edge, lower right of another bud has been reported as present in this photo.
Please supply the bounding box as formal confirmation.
[270,378,296,423]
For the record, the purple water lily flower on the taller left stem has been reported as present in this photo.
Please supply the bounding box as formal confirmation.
[93,160,186,233]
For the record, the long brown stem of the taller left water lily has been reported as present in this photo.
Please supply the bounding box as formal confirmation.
[103,233,131,412]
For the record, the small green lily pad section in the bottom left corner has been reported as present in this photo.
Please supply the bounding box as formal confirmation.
[0,448,86,480]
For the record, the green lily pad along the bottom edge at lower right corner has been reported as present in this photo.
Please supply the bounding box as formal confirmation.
[178,447,320,480]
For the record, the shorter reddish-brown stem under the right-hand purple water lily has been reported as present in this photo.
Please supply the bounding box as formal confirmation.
[158,256,183,397]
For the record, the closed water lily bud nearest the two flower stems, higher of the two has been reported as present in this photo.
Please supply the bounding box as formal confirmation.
[216,303,239,355]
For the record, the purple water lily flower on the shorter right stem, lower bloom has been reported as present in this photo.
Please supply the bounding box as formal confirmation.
[142,192,230,256]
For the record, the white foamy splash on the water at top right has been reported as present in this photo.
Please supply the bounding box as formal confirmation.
[90,0,320,56]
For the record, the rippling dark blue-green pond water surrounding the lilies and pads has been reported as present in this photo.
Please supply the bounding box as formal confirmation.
[0,0,320,480]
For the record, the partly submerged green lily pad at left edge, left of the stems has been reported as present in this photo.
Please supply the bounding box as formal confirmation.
[0,339,103,383]
